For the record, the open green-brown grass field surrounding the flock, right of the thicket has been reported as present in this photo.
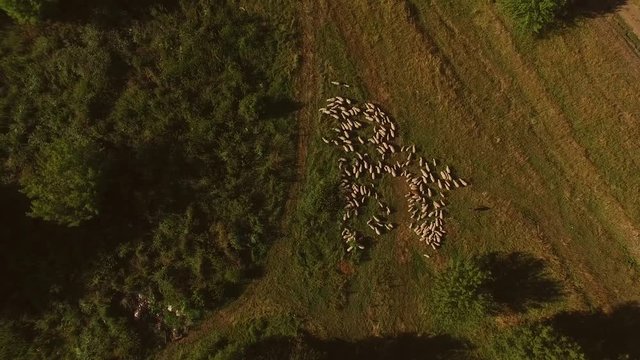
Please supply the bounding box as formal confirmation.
[165,0,640,359]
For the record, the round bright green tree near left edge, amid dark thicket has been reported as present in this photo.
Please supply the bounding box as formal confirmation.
[20,135,100,226]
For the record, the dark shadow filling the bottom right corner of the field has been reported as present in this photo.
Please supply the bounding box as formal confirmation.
[552,302,640,360]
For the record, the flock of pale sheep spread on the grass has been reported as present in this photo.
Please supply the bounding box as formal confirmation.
[320,88,467,257]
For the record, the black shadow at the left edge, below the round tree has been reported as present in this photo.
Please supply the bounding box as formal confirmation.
[0,185,97,318]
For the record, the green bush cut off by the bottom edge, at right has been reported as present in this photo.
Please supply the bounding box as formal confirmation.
[493,325,585,360]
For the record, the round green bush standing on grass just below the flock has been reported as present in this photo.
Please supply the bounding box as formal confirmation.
[432,260,492,328]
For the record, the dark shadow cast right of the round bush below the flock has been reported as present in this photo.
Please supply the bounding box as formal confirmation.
[481,252,563,312]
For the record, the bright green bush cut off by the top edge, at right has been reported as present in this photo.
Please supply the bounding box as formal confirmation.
[502,0,567,34]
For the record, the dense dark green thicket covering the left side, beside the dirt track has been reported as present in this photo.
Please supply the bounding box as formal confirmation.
[0,0,297,359]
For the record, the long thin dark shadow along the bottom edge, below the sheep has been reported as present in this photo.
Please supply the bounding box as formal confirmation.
[244,334,469,360]
